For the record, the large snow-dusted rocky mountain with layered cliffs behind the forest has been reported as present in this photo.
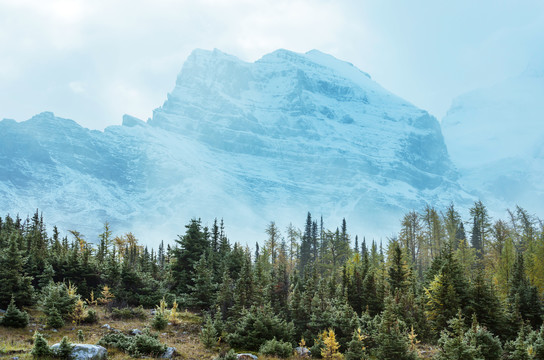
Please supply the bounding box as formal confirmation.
[0,50,471,243]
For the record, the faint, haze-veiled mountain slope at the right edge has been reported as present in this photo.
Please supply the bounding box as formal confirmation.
[442,61,544,217]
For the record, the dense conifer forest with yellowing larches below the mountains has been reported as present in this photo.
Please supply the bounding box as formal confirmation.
[0,201,544,360]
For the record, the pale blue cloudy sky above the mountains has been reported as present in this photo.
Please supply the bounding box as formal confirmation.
[0,0,544,129]
